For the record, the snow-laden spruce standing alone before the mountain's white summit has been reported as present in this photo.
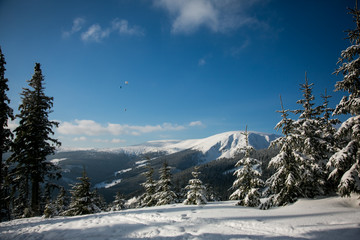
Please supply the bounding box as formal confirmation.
[229,126,264,207]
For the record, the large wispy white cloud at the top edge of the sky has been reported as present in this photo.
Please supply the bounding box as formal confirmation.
[154,0,261,34]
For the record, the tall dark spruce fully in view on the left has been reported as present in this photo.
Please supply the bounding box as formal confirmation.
[9,63,60,216]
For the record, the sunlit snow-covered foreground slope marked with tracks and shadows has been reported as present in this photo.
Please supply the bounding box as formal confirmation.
[0,197,360,240]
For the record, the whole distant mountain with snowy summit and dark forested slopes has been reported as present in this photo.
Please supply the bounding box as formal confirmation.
[49,131,278,199]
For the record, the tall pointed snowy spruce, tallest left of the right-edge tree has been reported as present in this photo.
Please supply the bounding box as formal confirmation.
[292,72,328,198]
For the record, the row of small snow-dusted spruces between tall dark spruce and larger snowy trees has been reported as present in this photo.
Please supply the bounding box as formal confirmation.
[40,161,207,217]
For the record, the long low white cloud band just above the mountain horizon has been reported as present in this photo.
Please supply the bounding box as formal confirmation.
[57,120,202,136]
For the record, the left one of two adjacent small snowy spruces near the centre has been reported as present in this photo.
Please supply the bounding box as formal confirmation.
[139,162,156,207]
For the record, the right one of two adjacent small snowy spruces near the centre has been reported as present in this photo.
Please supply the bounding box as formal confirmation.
[154,161,177,206]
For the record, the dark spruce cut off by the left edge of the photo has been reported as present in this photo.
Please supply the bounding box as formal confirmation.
[0,47,14,221]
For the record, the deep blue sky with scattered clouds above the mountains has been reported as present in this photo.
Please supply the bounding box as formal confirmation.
[0,0,355,148]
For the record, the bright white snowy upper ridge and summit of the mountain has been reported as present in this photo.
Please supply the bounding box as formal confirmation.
[116,131,279,162]
